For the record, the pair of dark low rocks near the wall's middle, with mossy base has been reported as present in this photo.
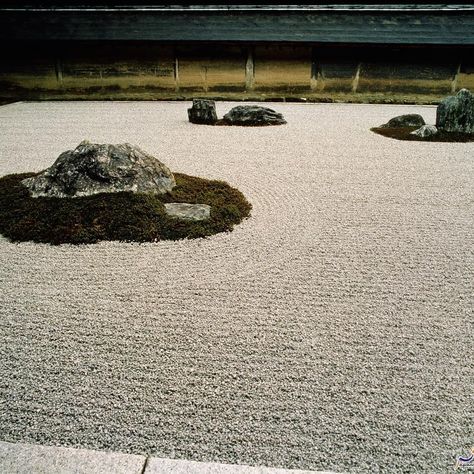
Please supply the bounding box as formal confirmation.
[188,99,286,127]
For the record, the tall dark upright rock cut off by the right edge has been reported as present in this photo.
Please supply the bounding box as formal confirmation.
[436,89,474,133]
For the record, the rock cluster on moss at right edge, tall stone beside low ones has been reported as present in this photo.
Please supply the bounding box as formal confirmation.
[371,89,474,142]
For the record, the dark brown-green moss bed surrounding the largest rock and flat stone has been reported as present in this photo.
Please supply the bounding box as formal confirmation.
[0,173,252,244]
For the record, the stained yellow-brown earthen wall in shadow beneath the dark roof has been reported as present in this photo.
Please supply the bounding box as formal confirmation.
[0,41,474,103]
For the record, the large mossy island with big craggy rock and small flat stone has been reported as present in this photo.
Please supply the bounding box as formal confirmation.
[0,141,251,244]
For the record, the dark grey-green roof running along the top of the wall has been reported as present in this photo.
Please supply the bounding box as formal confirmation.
[0,8,474,45]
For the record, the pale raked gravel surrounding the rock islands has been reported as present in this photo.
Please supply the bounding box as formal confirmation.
[0,102,474,473]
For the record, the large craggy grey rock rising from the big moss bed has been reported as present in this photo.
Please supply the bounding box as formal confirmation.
[22,141,176,197]
